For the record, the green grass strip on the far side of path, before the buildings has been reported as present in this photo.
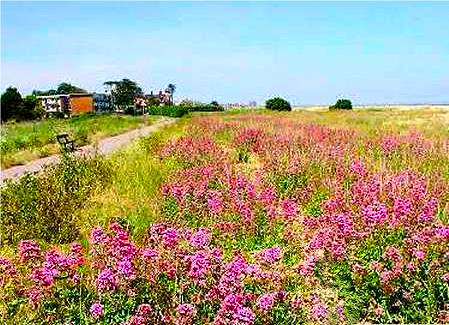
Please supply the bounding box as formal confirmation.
[0,114,157,168]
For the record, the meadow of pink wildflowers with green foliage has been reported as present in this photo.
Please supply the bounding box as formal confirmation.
[0,112,449,325]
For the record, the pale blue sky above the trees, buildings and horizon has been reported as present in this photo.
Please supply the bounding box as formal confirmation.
[1,1,449,105]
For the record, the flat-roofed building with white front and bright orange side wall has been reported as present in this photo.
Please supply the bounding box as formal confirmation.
[37,93,94,115]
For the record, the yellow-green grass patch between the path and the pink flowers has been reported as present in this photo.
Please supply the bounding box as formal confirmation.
[77,117,190,239]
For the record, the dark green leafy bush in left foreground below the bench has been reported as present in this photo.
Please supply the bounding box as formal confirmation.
[0,156,111,244]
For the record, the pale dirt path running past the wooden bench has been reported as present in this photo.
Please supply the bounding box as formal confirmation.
[0,117,175,183]
